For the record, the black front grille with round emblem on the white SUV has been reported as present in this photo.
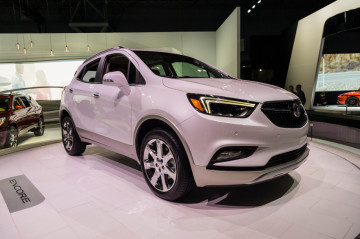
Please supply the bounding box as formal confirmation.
[261,100,307,128]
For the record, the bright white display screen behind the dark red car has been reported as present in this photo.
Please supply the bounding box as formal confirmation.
[0,59,84,100]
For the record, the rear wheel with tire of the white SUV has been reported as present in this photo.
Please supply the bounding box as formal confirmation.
[61,117,86,156]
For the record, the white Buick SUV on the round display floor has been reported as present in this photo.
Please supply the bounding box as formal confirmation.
[60,47,309,200]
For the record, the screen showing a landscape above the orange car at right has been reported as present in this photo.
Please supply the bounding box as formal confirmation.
[315,53,360,92]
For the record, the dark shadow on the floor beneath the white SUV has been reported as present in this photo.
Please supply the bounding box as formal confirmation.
[80,146,301,209]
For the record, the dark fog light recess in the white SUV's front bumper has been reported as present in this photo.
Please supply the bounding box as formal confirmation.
[209,146,257,165]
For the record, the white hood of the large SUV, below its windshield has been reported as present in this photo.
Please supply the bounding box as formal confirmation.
[163,78,298,102]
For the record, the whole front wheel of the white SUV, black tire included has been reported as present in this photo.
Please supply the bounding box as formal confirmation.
[140,128,195,201]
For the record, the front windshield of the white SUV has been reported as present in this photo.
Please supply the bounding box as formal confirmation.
[134,51,232,79]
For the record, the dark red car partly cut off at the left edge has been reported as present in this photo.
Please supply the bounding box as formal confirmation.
[0,94,44,147]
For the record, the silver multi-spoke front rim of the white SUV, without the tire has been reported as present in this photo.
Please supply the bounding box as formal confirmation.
[143,139,176,192]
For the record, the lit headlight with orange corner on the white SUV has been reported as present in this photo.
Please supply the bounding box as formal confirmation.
[187,94,257,118]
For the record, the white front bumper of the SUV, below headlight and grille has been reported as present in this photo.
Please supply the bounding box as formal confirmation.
[178,102,309,187]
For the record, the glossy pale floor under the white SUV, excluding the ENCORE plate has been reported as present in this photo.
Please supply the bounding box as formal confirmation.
[0,142,360,239]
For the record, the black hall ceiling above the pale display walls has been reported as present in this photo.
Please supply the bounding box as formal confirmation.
[0,0,334,34]
